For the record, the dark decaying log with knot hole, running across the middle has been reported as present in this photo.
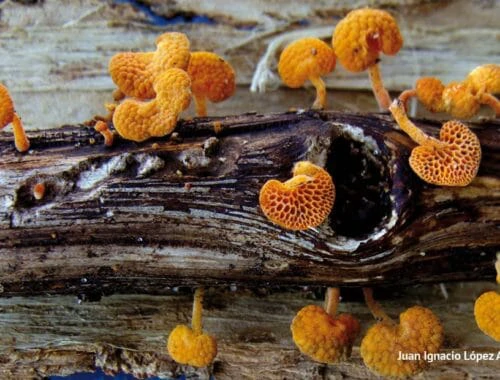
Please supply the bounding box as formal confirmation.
[0,112,500,295]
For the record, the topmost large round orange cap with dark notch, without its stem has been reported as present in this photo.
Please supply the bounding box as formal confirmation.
[332,8,403,72]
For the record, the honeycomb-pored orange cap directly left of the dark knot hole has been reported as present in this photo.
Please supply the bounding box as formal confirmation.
[259,161,335,230]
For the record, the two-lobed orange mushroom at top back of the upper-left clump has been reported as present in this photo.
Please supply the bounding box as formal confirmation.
[109,32,190,100]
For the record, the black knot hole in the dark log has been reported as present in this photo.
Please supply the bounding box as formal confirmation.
[326,137,391,238]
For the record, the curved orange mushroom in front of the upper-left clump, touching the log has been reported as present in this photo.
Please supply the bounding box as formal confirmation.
[113,68,191,141]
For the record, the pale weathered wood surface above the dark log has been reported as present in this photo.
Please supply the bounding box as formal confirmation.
[0,0,500,129]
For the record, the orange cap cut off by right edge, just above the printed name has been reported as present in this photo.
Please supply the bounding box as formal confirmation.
[474,291,500,342]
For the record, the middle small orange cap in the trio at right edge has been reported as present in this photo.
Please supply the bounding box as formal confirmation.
[443,82,481,119]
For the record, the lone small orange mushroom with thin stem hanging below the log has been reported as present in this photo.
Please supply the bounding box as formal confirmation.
[167,288,217,367]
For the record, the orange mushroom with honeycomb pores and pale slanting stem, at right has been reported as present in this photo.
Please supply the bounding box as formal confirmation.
[389,99,481,186]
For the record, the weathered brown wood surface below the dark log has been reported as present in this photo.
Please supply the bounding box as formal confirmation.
[0,283,500,380]
